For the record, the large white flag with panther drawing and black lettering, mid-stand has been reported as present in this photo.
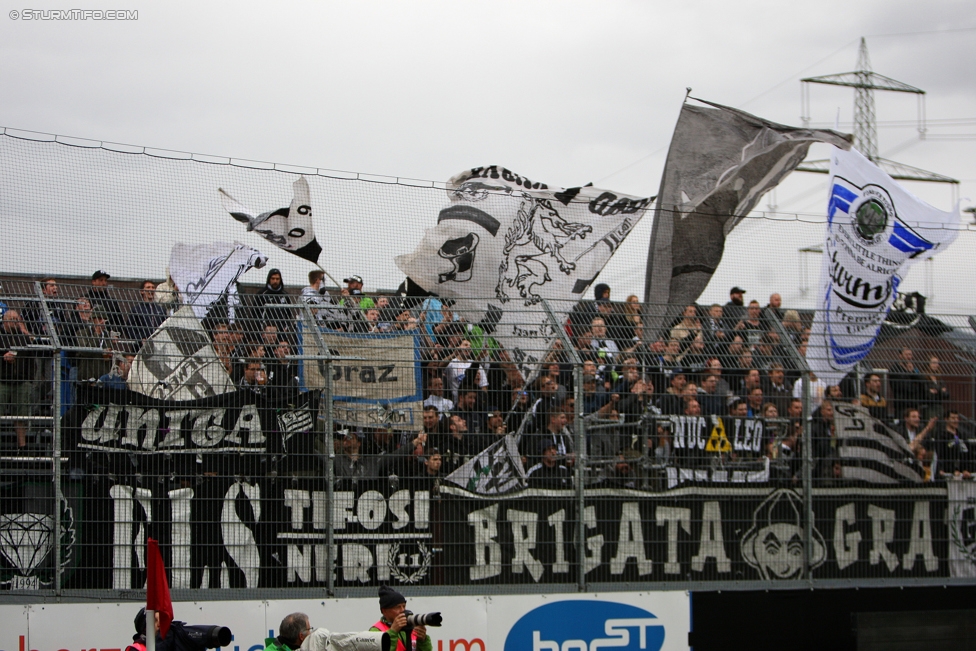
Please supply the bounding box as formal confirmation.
[396,165,653,372]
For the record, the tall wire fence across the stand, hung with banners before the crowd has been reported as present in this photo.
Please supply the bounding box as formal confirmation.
[0,282,976,598]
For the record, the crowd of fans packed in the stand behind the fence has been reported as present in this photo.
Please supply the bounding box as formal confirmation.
[0,269,976,488]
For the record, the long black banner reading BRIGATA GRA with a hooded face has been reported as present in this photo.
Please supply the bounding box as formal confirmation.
[442,487,949,584]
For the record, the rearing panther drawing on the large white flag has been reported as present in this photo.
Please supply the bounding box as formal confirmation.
[495,194,593,306]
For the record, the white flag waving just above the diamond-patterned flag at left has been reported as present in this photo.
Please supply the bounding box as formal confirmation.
[169,242,268,322]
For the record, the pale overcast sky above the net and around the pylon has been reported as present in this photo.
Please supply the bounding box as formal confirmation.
[0,0,976,311]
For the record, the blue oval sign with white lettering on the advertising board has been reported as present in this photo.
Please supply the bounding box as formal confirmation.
[505,600,664,651]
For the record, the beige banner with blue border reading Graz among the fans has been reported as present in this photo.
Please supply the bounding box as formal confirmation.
[299,329,423,431]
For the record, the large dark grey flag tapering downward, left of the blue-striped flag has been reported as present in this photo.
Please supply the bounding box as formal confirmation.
[644,98,851,340]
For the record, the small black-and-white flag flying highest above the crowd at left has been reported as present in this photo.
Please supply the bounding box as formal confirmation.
[217,176,322,263]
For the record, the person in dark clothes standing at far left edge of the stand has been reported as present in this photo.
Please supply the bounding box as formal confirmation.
[0,309,34,450]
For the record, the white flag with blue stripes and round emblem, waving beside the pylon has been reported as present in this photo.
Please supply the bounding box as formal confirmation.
[807,148,961,384]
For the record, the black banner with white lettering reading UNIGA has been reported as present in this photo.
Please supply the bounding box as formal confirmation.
[63,389,318,454]
